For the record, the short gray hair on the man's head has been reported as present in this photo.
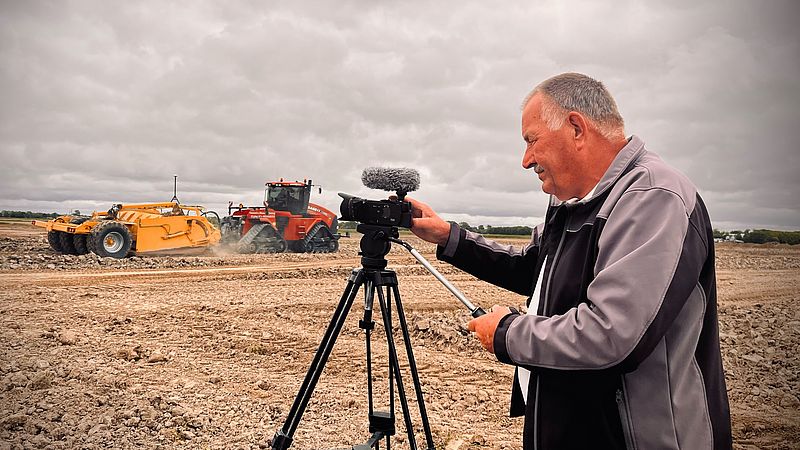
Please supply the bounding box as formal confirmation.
[522,73,625,140]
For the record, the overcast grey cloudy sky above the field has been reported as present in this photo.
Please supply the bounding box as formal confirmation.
[0,0,800,229]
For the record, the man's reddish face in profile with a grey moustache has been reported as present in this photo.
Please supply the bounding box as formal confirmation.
[522,94,580,200]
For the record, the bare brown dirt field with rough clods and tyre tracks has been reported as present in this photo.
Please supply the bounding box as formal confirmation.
[0,223,800,450]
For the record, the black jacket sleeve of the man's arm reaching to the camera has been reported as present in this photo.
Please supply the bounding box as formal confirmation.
[436,223,541,295]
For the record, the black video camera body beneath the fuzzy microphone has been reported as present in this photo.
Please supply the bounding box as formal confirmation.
[339,192,411,228]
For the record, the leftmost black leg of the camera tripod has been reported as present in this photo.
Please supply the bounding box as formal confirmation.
[272,269,364,450]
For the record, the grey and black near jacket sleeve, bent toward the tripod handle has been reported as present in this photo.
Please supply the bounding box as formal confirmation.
[494,188,707,370]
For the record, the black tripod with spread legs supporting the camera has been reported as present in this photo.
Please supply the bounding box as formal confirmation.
[272,224,434,450]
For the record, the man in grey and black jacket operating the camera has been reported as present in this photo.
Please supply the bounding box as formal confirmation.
[411,73,732,449]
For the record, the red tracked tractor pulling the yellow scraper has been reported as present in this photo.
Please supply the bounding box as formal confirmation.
[220,179,340,253]
